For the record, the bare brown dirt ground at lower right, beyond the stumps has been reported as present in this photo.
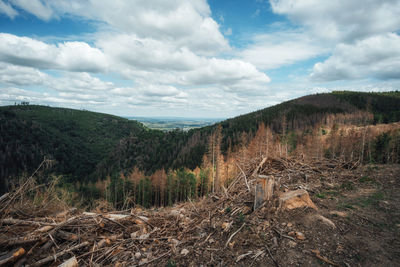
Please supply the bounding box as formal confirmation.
[250,165,400,266]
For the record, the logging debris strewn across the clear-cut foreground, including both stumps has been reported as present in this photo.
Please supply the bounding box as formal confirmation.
[0,158,400,267]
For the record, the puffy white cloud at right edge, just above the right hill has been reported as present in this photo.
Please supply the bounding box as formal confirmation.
[311,33,400,81]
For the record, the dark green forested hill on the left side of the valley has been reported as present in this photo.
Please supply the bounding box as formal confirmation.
[0,105,147,192]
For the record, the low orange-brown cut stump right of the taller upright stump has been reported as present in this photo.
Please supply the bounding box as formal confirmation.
[279,189,318,210]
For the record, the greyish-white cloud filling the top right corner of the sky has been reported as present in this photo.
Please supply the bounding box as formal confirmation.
[270,0,400,42]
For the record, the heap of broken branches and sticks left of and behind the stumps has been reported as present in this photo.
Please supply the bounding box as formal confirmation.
[0,158,356,266]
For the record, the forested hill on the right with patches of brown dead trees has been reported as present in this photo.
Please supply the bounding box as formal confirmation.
[96,91,400,177]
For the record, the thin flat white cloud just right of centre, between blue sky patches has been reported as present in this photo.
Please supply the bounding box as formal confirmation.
[237,30,327,70]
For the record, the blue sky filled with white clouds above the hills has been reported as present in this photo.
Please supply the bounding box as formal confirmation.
[0,0,400,118]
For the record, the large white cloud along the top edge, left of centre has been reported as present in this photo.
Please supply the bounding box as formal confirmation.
[4,0,229,56]
